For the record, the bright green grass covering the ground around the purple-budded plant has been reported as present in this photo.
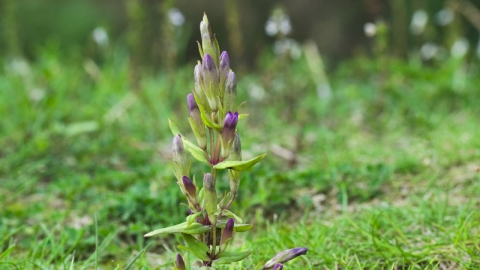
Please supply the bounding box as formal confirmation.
[0,45,480,269]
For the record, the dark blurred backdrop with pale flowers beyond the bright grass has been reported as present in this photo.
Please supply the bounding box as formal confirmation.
[0,0,480,68]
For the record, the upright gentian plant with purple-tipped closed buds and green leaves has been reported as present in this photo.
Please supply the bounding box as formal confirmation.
[145,15,307,270]
